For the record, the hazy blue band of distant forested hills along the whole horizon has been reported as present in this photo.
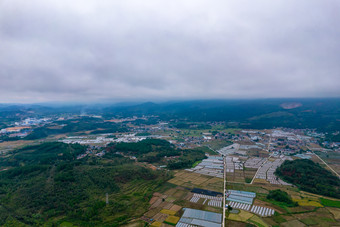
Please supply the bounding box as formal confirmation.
[0,98,340,132]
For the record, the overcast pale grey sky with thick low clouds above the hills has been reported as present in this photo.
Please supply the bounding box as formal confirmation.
[0,0,340,103]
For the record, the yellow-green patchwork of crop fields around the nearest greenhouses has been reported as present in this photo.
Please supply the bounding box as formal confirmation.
[131,167,340,227]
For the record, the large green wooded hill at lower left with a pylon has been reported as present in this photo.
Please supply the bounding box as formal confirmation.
[0,143,170,226]
